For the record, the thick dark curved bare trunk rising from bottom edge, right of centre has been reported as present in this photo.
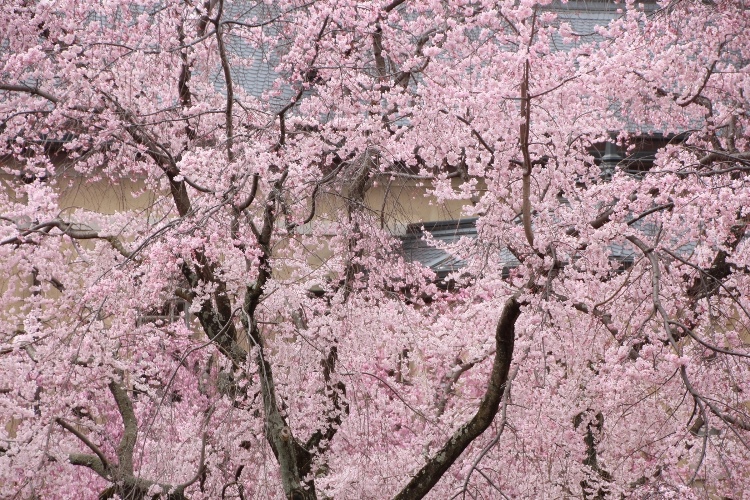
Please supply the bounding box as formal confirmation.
[394,297,521,500]
